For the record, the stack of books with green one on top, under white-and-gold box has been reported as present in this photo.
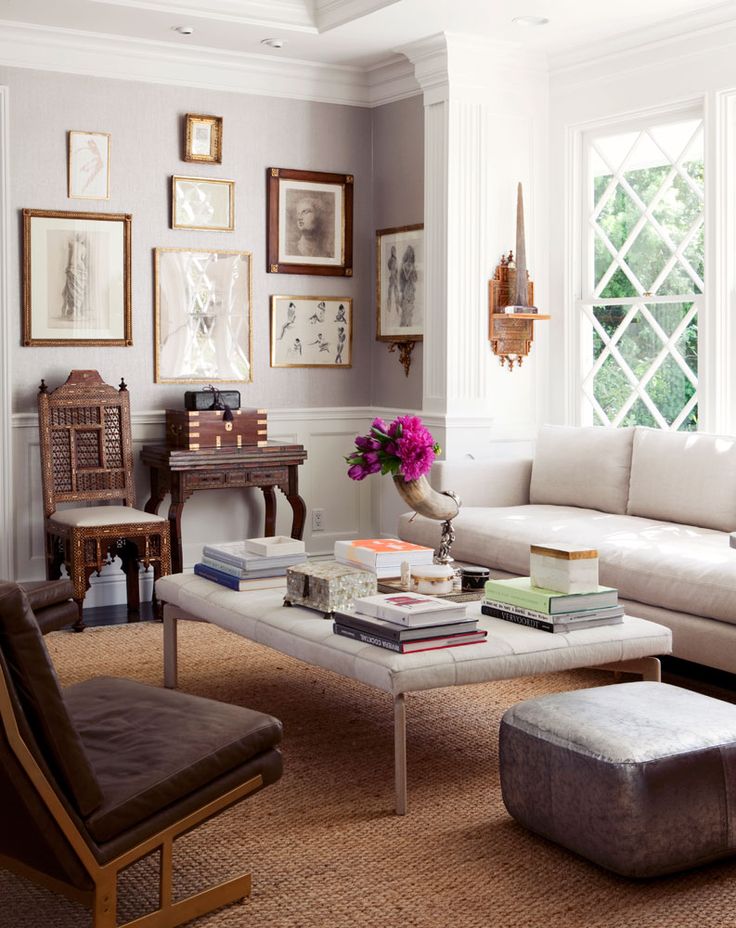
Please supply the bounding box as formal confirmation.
[481,577,624,632]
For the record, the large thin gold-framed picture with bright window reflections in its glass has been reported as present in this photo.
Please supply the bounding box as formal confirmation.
[154,248,253,383]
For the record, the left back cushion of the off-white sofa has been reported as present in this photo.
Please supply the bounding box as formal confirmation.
[529,425,634,514]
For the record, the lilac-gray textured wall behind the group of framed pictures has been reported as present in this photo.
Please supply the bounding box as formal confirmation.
[0,68,374,412]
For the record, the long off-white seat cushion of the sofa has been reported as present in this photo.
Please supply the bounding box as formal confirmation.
[399,506,736,625]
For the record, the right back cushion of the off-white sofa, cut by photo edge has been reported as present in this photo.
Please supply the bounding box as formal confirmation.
[627,427,736,532]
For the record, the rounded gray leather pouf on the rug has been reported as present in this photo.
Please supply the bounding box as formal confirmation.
[500,683,736,877]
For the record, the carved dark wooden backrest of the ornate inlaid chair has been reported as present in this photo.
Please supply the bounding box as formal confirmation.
[38,371,135,518]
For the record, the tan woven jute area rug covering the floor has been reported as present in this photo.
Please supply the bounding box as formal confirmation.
[0,623,736,928]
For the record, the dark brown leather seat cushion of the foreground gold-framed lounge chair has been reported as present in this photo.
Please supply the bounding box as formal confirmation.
[64,677,281,842]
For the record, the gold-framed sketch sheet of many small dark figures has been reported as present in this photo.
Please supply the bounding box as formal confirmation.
[271,296,353,367]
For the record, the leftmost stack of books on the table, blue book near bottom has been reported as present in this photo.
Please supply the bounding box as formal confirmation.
[194,535,307,591]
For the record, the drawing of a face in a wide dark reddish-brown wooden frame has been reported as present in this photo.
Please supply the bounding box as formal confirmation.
[266,168,353,277]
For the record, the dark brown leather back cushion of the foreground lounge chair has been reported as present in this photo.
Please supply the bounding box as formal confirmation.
[0,581,102,816]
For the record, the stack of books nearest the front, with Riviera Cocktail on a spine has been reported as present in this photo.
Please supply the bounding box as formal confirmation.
[333,593,488,654]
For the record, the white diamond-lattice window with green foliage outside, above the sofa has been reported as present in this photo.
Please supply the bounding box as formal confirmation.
[579,115,704,430]
